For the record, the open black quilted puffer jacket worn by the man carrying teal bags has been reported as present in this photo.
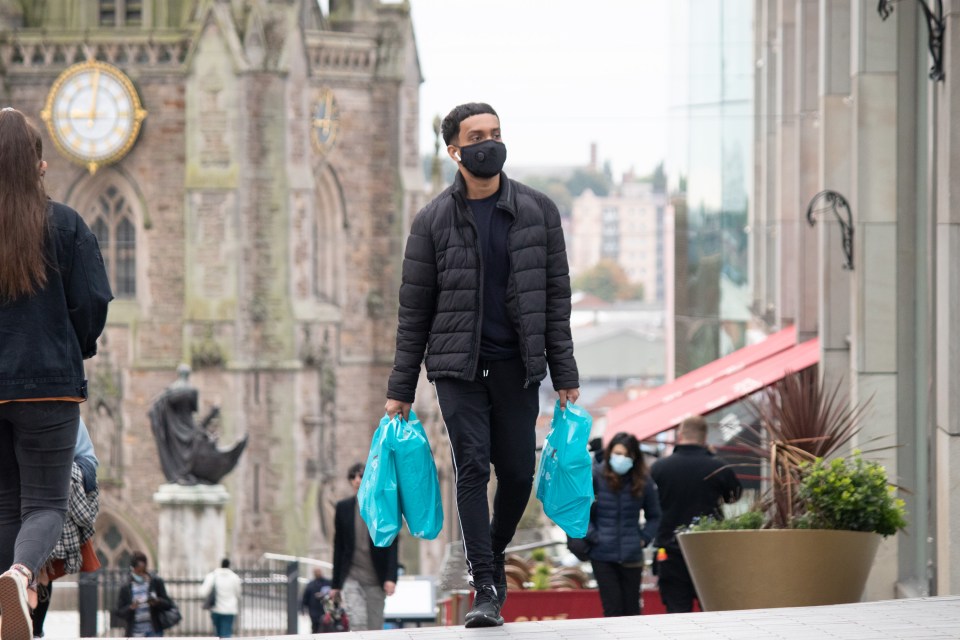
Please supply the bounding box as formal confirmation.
[387,173,580,402]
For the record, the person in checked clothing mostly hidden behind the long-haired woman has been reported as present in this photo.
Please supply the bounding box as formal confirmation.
[31,418,100,638]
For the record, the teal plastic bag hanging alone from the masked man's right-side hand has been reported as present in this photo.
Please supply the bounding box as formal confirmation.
[536,400,593,538]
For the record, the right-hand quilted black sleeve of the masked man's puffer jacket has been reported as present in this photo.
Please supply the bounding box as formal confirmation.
[543,198,580,391]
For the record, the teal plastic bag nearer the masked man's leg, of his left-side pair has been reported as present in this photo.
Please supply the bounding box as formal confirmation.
[393,411,443,540]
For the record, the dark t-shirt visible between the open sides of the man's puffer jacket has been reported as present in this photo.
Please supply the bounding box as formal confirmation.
[467,192,520,360]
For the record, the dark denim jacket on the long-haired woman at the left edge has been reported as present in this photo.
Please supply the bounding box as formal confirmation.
[0,201,113,400]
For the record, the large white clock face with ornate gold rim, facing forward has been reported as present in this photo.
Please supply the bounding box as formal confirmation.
[40,60,147,173]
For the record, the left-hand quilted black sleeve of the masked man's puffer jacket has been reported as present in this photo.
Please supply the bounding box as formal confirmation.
[387,209,437,402]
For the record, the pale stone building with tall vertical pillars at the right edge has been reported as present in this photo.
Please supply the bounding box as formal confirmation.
[750,0,960,599]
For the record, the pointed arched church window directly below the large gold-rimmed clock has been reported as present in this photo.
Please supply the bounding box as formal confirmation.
[85,185,137,298]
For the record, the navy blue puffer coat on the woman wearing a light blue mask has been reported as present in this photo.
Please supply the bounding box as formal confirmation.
[587,463,660,564]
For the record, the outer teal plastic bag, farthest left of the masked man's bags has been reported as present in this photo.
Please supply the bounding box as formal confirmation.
[357,415,401,547]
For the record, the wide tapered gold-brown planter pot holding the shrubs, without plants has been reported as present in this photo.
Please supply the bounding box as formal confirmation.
[678,529,881,611]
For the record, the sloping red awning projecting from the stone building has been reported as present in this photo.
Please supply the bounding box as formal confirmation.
[605,334,820,440]
